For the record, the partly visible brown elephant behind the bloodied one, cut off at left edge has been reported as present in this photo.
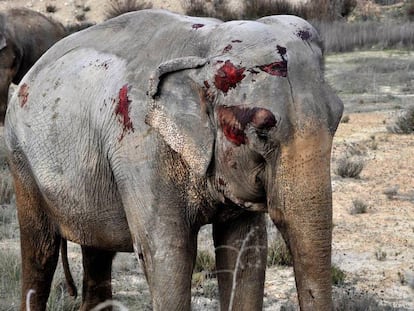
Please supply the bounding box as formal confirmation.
[0,8,66,125]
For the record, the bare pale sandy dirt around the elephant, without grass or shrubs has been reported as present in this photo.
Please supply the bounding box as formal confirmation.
[0,0,414,310]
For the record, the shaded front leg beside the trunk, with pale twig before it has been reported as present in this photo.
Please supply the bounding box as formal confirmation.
[213,213,267,311]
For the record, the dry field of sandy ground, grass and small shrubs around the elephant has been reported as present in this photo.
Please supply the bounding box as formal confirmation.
[0,0,414,311]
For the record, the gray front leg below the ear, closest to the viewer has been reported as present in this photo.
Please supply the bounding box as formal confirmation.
[138,220,197,311]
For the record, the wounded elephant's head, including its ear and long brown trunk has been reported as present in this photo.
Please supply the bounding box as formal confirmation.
[147,16,343,310]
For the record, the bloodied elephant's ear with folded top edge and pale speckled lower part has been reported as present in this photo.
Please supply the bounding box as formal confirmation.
[146,57,214,175]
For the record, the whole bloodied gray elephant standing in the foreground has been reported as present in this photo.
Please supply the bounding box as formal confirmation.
[5,10,343,310]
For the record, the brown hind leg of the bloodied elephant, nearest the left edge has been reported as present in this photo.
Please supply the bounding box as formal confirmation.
[12,169,61,311]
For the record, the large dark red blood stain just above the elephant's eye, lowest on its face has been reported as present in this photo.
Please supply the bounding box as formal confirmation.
[217,106,277,146]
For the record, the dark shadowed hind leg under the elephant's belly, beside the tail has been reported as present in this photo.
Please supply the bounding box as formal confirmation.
[81,246,115,311]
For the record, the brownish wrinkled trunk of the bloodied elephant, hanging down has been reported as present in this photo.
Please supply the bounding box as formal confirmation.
[268,129,332,311]
